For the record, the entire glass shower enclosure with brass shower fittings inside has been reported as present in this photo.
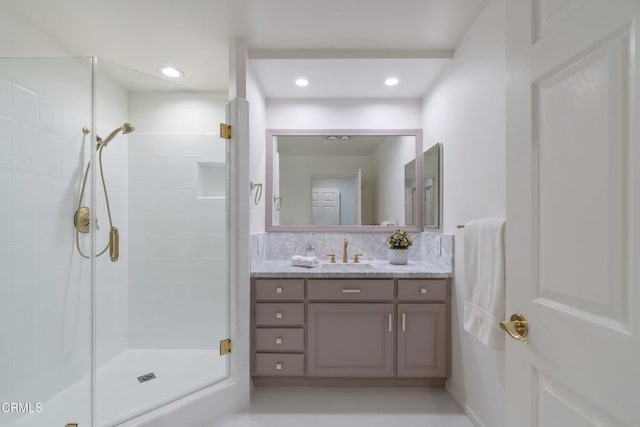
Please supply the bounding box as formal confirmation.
[0,58,229,427]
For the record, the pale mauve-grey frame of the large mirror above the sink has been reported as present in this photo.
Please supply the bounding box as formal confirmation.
[265,129,423,233]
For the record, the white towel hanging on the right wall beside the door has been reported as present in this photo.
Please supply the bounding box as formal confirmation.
[464,218,505,350]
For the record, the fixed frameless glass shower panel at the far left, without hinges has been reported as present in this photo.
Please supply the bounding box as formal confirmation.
[0,58,92,427]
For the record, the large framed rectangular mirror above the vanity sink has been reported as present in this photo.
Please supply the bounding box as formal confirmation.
[265,129,423,232]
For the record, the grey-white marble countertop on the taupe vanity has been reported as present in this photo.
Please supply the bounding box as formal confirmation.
[251,260,453,279]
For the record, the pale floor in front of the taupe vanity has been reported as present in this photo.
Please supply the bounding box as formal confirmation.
[214,387,473,427]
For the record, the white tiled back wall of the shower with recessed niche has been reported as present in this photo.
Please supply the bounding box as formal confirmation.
[128,92,228,348]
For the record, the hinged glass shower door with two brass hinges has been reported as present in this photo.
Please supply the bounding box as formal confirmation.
[95,60,229,426]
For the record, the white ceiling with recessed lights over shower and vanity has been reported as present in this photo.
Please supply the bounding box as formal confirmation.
[0,0,488,97]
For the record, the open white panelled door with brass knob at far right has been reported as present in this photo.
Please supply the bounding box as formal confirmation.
[505,0,640,427]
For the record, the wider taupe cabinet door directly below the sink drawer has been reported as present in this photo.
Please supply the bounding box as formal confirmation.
[307,303,395,377]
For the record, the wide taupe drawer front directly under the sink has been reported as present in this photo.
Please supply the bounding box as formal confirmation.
[307,279,393,301]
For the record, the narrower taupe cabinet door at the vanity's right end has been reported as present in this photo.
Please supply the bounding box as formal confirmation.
[398,304,447,377]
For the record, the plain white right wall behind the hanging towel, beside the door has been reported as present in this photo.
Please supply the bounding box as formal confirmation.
[423,0,506,427]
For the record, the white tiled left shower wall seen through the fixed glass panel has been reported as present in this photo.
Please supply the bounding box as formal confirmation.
[0,79,91,412]
